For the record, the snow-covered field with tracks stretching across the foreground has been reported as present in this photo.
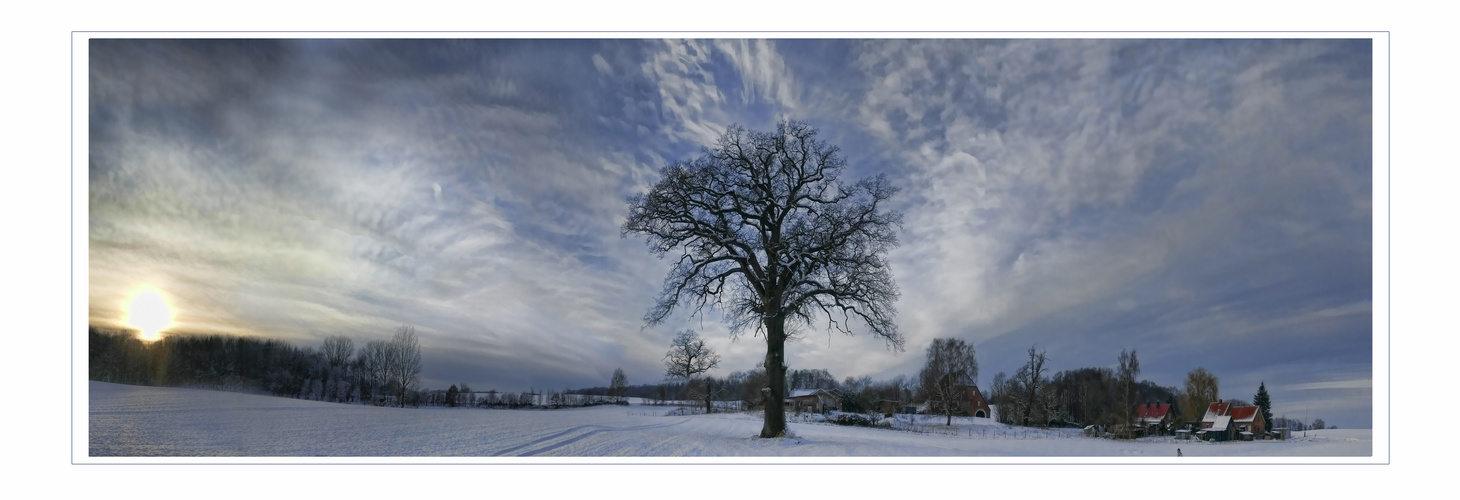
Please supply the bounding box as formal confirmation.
[85,382,1374,463]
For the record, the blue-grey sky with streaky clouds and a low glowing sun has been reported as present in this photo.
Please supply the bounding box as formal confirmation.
[77,38,1387,428]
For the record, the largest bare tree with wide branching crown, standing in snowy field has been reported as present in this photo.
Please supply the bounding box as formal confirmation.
[623,121,904,437]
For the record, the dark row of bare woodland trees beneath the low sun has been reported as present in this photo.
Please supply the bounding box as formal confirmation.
[88,326,423,406]
